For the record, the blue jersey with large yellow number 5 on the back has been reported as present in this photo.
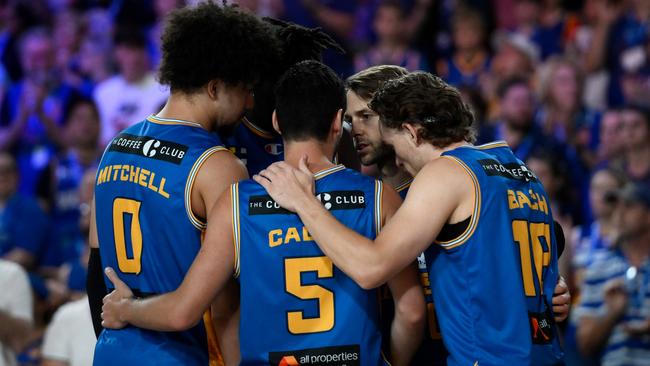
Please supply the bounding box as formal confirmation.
[231,165,386,365]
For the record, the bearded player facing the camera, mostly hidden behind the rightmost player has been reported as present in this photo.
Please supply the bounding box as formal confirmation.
[345,65,570,365]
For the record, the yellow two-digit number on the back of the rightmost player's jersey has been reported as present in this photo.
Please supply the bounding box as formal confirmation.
[512,220,552,296]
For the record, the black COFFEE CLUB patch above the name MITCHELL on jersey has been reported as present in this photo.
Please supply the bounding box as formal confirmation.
[108,133,188,165]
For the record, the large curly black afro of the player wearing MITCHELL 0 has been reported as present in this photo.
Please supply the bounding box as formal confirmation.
[159,1,278,93]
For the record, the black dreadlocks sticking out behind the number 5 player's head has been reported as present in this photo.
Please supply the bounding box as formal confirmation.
[248,18,344,131]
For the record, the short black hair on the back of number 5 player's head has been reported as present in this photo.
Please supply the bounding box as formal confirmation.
[275,61,345,141]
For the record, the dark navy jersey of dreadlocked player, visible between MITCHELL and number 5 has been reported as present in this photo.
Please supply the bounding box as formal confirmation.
[226,118,284,177]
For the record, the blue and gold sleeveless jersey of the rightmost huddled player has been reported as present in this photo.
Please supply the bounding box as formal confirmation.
[425,142,562,366]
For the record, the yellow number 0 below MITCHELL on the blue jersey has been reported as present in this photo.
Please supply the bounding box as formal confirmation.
[113,198,142,274]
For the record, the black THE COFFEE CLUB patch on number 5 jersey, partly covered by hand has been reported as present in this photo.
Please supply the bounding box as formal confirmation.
[248,191,366,215]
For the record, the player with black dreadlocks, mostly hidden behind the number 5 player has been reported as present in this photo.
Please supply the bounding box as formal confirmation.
[226,18,359,175]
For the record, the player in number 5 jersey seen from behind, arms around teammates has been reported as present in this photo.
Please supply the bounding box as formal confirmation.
[98,61,424,365]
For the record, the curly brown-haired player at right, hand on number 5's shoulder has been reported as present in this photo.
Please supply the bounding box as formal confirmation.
[254,72,562,365]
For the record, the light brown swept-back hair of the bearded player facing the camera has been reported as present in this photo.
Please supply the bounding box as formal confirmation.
[345,65,408,100]
